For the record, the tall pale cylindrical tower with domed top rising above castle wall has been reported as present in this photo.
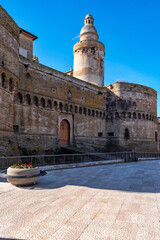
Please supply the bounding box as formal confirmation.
[73,14,105,86]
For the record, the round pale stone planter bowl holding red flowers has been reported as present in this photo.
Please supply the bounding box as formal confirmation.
[7,167,40,186]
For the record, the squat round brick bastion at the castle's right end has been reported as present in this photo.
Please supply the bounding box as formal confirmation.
[106,82,158,151]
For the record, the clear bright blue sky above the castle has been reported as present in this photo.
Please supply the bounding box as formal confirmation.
[0,0,160,116]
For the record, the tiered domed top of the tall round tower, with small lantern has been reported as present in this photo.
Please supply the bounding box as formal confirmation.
[79,14,99,41]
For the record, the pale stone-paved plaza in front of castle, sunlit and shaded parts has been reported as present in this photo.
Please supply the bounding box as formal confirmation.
[0,161,160,240]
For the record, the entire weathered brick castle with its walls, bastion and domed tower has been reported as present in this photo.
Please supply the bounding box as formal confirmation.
[0,6,159,156]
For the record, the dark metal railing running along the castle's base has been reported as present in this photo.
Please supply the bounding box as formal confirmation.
[0,152,160,169]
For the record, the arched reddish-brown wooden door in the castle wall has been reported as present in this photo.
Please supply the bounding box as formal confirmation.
[60,120,70,146]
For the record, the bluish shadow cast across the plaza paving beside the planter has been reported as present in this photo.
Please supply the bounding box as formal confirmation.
[0,160,160,193]
